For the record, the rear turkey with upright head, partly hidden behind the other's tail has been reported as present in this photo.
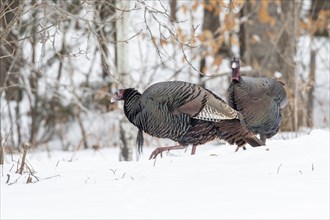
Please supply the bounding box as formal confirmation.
[228,58,288,143]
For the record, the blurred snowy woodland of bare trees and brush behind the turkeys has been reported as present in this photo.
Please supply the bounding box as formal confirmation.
[0,0,330,164]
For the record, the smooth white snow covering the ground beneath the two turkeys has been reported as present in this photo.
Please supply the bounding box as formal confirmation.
[0,130,330,219]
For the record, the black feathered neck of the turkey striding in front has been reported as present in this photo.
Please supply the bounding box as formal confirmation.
[124,89,141,123]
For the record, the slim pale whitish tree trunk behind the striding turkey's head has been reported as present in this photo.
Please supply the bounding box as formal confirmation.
[116,1,135,161]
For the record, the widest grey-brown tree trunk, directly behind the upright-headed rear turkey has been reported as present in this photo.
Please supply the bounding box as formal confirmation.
[240,0,302,131]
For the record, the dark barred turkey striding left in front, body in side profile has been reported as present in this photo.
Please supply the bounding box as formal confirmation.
[112,81,264,159]
